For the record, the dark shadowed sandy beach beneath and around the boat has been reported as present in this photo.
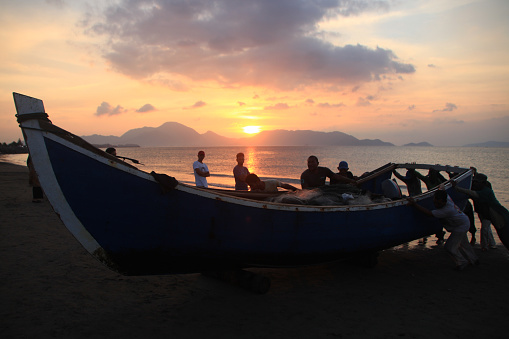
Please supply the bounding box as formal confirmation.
[0,162,509,338]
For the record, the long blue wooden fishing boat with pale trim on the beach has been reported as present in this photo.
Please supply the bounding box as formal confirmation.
[14,93,472,275]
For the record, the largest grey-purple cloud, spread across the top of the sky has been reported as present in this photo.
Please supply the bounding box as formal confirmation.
[84,0,415,89]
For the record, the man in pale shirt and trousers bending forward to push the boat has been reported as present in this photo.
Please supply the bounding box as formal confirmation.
[408,189,479,271]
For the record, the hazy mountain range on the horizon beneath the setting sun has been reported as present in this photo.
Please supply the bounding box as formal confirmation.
[82,122,394,147]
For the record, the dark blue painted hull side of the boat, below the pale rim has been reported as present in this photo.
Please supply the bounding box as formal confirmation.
[45,139,456,274]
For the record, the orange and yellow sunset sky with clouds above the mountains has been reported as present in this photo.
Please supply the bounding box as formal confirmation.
[0,0,509,146]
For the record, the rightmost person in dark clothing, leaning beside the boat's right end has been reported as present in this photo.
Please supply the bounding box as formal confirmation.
[451,168,509,251]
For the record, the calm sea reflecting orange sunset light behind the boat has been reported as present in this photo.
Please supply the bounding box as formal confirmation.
[0,146,509,248]
